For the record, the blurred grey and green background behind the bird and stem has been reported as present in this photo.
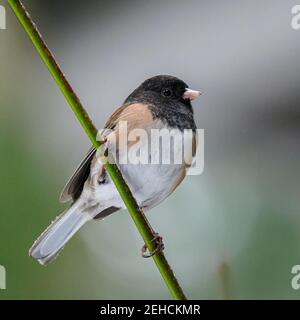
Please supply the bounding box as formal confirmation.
[0,0,300,299]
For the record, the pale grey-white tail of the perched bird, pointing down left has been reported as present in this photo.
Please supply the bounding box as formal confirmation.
[29,202,91,265]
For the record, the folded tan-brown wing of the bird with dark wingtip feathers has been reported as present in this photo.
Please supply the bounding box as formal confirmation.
[59,103,152,202]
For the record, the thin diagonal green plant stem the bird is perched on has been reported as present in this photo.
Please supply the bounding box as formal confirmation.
[7,0,186,300]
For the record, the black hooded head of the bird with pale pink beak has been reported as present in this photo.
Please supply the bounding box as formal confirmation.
[125,75,200,127]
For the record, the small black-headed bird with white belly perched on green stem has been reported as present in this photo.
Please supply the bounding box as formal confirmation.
[29,75,201,265]
